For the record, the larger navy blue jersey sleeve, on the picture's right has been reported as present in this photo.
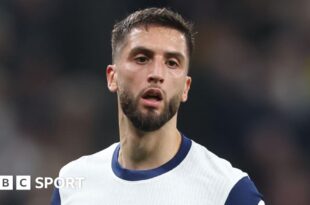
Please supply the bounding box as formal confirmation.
[225,176,265,205]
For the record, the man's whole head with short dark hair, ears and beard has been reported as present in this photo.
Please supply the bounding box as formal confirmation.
[107,8,193,132]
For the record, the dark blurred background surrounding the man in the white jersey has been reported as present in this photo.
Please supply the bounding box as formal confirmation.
[0,0,310,205]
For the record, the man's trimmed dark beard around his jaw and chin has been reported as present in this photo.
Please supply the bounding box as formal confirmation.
[119,86,181,132]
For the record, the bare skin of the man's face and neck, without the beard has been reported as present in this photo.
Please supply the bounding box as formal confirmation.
[106,25,191,170]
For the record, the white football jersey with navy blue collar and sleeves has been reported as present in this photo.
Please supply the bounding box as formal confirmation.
[52,135,264,205]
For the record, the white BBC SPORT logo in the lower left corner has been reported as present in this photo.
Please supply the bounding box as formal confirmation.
[0,175,84,190]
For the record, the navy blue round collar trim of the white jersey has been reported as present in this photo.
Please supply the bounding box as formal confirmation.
[112,134,192,181]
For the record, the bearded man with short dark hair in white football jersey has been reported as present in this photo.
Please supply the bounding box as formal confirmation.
[52,8,264,205]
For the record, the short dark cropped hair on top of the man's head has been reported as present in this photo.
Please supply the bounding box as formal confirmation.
[111,7,194,61]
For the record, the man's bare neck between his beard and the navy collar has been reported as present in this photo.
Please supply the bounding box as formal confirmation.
[118,110,181,170]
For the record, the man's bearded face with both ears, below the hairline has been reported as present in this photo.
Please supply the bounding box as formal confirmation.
[107,26,191,131]
